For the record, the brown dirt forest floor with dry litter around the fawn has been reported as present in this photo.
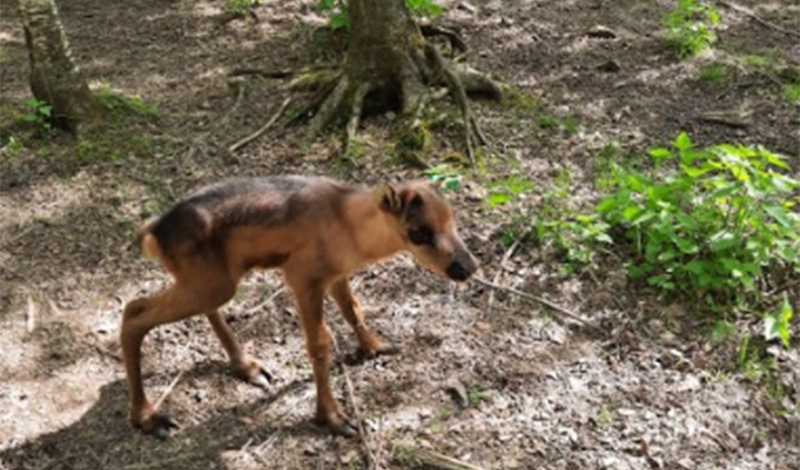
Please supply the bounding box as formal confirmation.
[0,0,800,470]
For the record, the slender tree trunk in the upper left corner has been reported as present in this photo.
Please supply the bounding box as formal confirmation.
[17,0,99,133]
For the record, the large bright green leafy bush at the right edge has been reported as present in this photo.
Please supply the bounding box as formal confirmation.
[596,133,800,312]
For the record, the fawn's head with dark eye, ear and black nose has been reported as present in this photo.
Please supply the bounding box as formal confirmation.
[376,181,478,282]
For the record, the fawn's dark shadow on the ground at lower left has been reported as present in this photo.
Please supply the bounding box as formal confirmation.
[0,370,318,470]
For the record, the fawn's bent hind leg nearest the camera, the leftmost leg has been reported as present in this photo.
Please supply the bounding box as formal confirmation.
[120,276,235,437]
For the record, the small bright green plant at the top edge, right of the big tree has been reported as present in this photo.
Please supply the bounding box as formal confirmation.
[661,0,719,59]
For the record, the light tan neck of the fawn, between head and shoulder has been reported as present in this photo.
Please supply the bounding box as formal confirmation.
[344,190,403,262]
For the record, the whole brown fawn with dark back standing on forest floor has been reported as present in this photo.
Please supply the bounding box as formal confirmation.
[121,176,476,435]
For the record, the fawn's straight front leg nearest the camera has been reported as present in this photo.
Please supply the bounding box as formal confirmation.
[287,279,357,437]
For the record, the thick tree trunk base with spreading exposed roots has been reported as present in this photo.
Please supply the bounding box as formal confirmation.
[300,0,501,160]
